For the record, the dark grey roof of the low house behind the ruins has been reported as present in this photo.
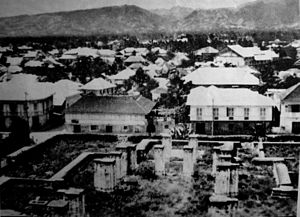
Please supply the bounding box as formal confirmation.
[66,95,155,115]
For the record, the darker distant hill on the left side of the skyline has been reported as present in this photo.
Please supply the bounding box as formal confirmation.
[0,5,168,36]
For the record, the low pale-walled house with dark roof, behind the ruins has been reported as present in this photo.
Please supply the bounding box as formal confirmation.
[66,96,155,134]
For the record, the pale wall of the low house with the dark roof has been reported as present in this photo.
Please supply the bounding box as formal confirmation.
[66,114,147,133]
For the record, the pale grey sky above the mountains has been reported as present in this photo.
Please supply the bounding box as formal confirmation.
[0,0,255,17]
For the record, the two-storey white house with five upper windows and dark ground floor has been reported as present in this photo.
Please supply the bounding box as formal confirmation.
[186,86,274,135]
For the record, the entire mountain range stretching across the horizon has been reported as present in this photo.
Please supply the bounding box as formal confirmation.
[0,0,300,37]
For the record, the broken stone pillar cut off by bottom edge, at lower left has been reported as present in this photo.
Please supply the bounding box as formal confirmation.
[57,188,85,217]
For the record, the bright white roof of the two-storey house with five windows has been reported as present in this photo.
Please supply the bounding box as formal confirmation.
[187,86,275,106]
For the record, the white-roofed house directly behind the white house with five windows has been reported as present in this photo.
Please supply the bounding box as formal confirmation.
[182,67,260,88]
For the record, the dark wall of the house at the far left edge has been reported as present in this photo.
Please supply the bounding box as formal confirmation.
[0,96,53,130]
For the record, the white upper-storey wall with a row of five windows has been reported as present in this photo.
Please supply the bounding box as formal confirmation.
[190,106,272,122]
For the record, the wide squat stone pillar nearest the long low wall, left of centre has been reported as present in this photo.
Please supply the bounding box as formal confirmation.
[94,158,117,192]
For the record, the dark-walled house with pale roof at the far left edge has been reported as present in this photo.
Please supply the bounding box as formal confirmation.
[0,78,54,131]
